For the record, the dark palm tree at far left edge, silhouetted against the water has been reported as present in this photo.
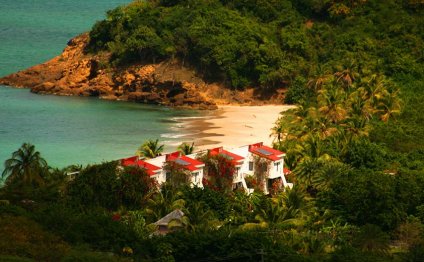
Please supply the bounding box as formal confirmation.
[2,143,48,186]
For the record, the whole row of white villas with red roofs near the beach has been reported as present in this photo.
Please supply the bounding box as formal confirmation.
[121,143,293,194]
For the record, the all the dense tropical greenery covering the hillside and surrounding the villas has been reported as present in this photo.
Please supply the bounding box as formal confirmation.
[0,0,424,261]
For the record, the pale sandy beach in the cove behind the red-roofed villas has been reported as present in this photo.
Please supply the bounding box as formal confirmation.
[184,105,294,150]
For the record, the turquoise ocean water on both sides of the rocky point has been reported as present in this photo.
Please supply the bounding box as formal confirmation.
[0,0,198,168]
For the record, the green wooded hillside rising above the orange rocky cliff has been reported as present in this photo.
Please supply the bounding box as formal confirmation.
[89,0,424,90]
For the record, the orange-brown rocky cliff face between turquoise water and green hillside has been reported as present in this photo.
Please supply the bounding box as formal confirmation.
[0,34,283,109]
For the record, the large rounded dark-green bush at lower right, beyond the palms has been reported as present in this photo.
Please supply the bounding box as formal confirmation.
[317,170,406,230]
